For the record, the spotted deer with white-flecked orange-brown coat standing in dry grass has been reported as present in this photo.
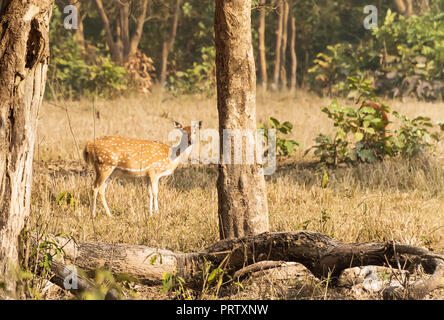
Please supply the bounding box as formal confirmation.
[83,121,202,217]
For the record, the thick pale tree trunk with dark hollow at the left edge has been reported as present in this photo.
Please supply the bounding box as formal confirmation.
[0,0,53,290]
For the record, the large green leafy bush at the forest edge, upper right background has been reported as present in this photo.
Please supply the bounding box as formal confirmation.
[308,10,444,100]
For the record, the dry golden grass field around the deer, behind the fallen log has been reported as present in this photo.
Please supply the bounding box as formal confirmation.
[30,89,444,300]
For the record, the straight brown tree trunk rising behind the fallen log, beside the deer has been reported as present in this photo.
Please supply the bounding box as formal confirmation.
[214,0,269,239]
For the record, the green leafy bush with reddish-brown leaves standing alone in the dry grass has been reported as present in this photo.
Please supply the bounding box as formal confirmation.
[306,100,438,166]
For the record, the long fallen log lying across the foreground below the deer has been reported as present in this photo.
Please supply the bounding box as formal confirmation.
[33,231,444,299]
